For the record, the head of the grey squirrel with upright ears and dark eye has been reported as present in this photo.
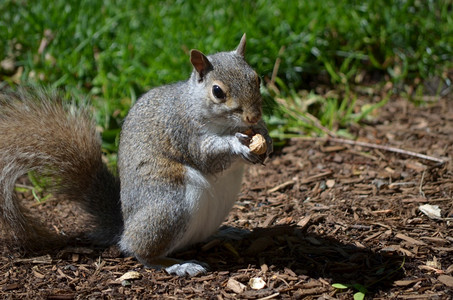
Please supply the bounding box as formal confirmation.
[190,34,262,128]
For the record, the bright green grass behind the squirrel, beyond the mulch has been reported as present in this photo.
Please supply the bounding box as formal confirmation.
[0,0,453,150]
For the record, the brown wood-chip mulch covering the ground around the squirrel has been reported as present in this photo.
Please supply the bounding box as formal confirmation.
[0,99,453,299]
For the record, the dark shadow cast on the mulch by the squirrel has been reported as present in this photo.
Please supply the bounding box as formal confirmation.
[172,225,405,292]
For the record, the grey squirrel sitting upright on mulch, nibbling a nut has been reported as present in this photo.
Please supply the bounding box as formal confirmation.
[0,34,272,276]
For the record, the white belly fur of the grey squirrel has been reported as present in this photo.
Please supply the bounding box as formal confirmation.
[171,162,244,252]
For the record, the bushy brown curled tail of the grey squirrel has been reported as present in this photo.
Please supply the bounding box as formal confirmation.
[0,89,123,249]
